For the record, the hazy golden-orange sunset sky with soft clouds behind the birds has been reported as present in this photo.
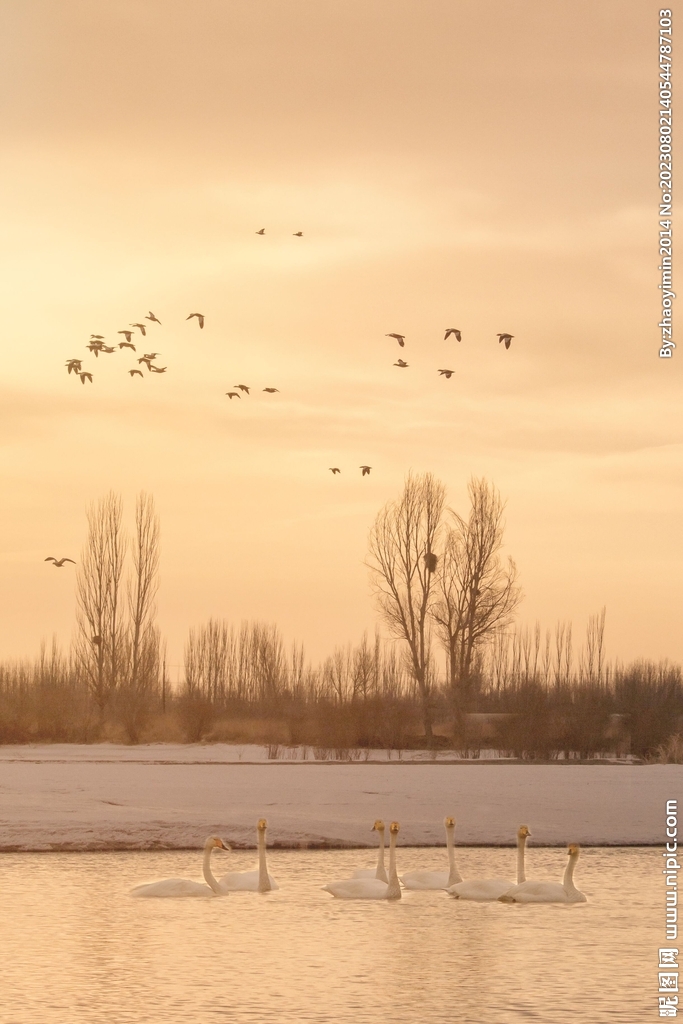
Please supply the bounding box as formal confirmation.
[0,0,683,672]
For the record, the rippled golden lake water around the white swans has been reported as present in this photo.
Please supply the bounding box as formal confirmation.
[0,847,667,1024]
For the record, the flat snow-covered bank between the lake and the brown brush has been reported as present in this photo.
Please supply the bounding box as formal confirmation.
[0,743,683,851]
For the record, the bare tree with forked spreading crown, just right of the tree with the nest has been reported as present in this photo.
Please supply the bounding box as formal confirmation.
[433,477,520,723]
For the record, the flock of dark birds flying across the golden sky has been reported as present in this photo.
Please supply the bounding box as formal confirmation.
[54,227,514,568]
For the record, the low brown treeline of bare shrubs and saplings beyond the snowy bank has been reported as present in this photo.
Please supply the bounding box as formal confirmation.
[0,621,683,761]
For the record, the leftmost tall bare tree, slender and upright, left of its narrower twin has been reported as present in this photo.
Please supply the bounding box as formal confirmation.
[76,492,126,718]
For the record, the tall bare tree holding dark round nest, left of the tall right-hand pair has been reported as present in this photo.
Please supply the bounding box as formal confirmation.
[367,473,445,743]
